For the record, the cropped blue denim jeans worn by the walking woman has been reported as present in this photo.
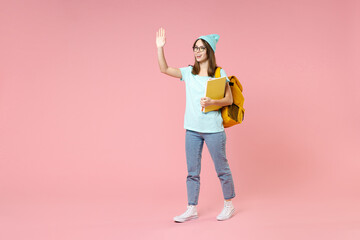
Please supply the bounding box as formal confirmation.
[185,130,235,205]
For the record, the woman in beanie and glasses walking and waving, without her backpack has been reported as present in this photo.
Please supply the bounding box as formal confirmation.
[156,28,235,222]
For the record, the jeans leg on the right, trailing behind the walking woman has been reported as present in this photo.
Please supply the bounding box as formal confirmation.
[204,131,235,200]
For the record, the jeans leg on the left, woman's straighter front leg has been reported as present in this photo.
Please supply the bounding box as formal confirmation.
[185,130,204,205]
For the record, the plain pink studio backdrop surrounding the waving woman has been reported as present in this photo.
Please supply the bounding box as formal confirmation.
[0,0,360,240]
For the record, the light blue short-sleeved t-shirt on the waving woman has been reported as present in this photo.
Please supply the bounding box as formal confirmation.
[180,66,230,133]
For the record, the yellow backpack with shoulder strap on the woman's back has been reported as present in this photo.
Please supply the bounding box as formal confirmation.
[215,67,245,128]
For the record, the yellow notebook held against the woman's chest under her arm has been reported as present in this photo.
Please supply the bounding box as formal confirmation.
[203,77,226,113]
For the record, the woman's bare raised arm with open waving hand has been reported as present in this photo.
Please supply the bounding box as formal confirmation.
[156,28,182,78]
